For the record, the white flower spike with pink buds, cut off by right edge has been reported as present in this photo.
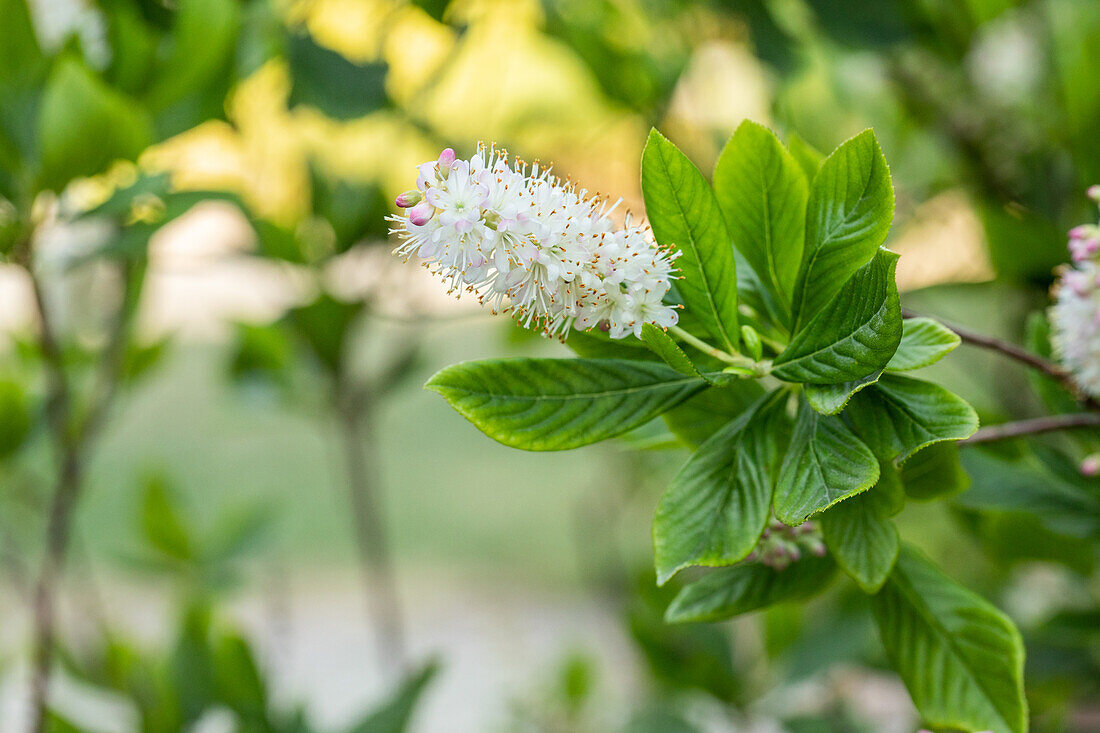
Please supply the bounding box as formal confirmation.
[1048,186,1100,397]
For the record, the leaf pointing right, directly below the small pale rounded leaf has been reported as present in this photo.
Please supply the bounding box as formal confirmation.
[846,374,978,462]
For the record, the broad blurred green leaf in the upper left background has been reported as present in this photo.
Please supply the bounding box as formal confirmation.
[39,57,153,192]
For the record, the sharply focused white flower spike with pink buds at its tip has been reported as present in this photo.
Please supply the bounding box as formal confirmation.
[389,146,679,339]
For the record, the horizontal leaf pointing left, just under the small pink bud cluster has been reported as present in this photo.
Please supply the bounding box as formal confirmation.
[664,556,836,623]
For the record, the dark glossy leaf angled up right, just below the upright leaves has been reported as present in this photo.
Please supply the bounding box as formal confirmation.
[772,250,902,384]
